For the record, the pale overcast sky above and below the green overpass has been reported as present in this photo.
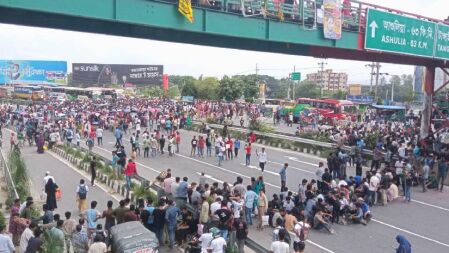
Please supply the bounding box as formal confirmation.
[0,0,449,85]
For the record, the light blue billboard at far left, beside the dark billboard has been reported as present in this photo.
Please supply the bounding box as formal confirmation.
[0,60,67,85]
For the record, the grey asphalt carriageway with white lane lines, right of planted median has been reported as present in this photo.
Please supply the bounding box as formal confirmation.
[76,128,449,253]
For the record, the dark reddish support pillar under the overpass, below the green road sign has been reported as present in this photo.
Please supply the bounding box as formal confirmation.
[420,66,435,139]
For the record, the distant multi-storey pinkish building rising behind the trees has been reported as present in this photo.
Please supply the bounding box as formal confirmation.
[307,69,348,91]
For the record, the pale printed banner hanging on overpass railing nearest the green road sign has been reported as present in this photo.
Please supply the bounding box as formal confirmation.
[323,0,342,40]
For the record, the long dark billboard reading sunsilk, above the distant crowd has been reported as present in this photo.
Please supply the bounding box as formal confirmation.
[72,63,164,86]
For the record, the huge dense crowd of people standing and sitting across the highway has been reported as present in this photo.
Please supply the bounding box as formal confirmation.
[0,99,430,253]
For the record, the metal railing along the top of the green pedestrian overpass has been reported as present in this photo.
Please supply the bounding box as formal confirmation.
[156,0,448,33]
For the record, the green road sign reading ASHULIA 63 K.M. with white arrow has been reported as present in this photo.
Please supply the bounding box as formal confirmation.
[365,9,449,59]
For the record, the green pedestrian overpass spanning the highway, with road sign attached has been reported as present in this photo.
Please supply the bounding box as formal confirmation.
[0,0,449,136]
